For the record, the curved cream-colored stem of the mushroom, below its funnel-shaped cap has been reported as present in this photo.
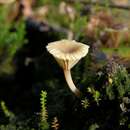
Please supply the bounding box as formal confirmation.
[64,70,80,97]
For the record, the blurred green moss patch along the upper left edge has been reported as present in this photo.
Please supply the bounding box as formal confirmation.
[0,6,25,73]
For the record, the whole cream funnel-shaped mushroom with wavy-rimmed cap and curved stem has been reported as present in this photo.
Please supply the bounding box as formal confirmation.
[46,40,89,97]
